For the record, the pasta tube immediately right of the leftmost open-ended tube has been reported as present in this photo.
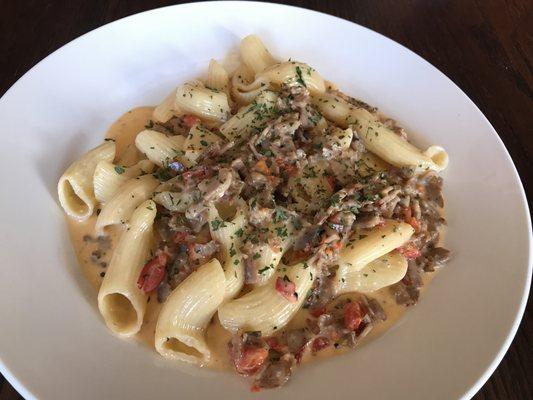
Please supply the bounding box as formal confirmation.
[93,160,154,204]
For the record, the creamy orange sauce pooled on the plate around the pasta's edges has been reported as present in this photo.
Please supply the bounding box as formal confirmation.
[67,107,434,370]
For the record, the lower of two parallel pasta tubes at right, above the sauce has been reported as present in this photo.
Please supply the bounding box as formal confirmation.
[333,251,407,296]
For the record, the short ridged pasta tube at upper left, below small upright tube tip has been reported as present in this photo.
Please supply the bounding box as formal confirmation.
[174,83,230,123]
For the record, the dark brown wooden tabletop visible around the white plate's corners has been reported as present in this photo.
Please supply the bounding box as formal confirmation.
[0,0,533,400]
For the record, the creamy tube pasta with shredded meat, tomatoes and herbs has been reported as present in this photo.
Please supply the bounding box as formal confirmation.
[58,35,449,391]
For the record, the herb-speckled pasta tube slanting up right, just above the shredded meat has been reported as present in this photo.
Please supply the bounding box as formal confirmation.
[220,90,278,142]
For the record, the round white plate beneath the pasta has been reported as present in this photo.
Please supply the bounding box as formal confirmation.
[0,2,531,400]
